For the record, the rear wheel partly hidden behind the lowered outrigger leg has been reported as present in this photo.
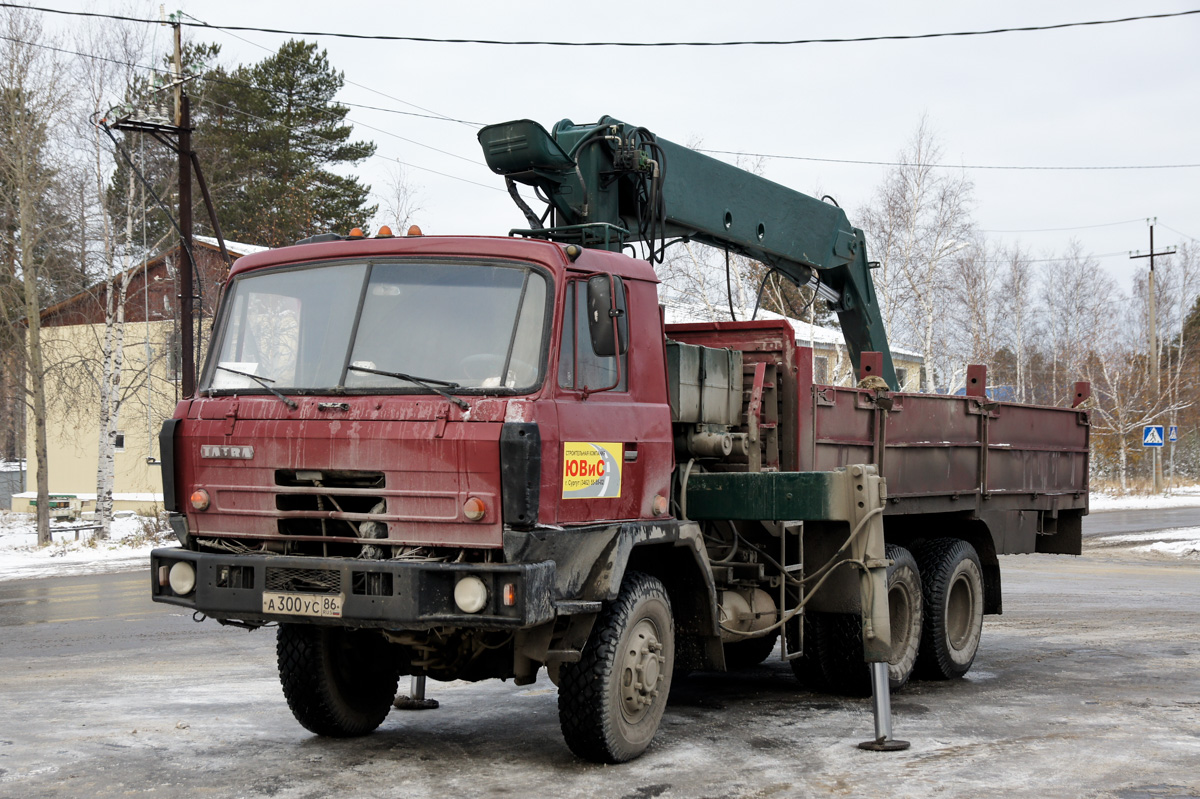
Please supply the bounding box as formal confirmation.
[792,543,924,696]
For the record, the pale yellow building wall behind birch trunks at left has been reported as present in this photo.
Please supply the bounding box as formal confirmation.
[23,320,178,512]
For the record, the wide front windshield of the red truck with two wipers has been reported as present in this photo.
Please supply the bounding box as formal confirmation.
[200,262,547,392]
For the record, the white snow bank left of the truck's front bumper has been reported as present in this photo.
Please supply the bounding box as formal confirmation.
[0,511,175,579]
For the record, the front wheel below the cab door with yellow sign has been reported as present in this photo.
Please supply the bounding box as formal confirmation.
[558,571,674,763]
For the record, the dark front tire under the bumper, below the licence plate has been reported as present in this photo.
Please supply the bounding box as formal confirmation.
[275,624,400,738]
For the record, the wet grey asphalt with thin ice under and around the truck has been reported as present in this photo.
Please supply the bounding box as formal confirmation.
[0,549,1200,799]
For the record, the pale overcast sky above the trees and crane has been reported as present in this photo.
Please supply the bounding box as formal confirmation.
[40,0,1200,289]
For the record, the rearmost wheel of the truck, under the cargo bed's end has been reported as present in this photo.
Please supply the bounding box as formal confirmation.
[917,539,983,680]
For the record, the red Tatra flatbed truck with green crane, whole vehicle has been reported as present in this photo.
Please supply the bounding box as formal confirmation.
[151,118,1088,762]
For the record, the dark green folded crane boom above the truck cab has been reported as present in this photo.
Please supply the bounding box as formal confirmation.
[479,116,899,390]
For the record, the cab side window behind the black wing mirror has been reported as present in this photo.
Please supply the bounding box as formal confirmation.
[558,275,629,394]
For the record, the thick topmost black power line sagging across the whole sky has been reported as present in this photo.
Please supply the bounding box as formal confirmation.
[0,2,1200,47]
